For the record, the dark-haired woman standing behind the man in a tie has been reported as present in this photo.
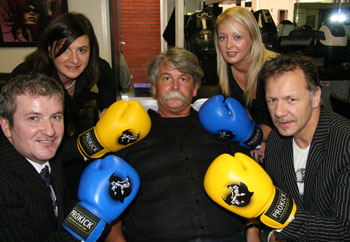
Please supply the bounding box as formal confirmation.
[12,10,116,197]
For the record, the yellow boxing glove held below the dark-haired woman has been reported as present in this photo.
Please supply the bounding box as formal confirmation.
[78,100,151,158]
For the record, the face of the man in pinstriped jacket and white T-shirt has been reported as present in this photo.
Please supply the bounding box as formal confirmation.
[266,69,321,141]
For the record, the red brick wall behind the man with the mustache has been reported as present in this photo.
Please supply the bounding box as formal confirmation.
[121,0,161,84]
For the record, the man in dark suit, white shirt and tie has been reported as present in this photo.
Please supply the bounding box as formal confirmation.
[0,74,75,241]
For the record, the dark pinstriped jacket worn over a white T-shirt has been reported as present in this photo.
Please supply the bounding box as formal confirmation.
[265,110,350,242]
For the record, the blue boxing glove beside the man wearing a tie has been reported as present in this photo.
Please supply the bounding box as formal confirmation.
[63,155,140,242]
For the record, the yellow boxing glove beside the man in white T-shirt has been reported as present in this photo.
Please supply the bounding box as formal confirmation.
[204,153,296,229]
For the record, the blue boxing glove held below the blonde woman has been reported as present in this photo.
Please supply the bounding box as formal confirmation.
[199,95,263,149]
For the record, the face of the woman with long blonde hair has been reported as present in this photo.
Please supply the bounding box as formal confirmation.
[217,19,253,65]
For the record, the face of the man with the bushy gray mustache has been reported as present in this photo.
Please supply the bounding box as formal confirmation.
[152,63,198,117]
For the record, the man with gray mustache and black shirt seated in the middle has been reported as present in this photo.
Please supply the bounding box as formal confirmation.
[106,47,248,242]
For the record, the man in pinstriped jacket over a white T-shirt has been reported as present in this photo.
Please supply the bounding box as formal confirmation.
[247,55,350,242]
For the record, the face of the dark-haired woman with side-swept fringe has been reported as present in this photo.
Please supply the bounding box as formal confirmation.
[51,35,90,84]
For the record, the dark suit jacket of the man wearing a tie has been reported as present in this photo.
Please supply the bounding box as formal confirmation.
[0,138,75,241]
